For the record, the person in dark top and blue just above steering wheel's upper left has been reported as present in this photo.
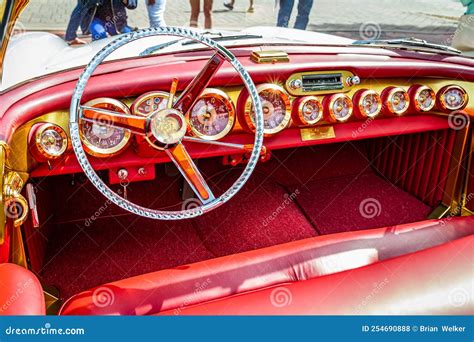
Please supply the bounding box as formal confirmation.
[82,0,137,40]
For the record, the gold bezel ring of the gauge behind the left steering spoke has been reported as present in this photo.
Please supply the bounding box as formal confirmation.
[79,97,132,158]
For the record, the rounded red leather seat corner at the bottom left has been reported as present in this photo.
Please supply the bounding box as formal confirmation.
[0,264,46,315]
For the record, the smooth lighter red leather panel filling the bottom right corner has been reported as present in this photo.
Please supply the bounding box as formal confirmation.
[162,235,474,315]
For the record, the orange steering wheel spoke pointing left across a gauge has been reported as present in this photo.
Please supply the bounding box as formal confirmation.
[80,106,147,135]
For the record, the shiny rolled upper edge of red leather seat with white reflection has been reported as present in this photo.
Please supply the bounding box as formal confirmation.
[60,217,474,315]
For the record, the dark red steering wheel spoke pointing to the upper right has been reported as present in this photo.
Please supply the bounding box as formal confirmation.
[173,52,225,114]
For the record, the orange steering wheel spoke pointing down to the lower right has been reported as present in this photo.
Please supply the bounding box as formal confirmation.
[166,143,215,204]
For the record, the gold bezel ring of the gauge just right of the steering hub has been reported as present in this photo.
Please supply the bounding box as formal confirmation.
[186,88,235,140]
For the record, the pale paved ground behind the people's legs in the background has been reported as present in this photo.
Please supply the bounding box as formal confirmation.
[16,0,464,41]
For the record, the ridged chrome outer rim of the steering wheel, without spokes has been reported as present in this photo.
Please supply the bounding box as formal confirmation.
[69,27,264,220]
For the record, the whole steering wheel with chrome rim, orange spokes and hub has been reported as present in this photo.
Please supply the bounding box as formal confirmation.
[69,27,263,220]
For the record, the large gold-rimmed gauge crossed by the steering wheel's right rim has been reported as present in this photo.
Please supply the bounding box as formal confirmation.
[245,84,291,135]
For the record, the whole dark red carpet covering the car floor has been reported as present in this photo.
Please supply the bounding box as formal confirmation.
[40,144,430,298]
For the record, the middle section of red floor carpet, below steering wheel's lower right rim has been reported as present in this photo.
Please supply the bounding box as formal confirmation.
[193,173,317,256]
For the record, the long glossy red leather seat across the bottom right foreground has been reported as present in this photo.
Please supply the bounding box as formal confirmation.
[60,217,474,315]
